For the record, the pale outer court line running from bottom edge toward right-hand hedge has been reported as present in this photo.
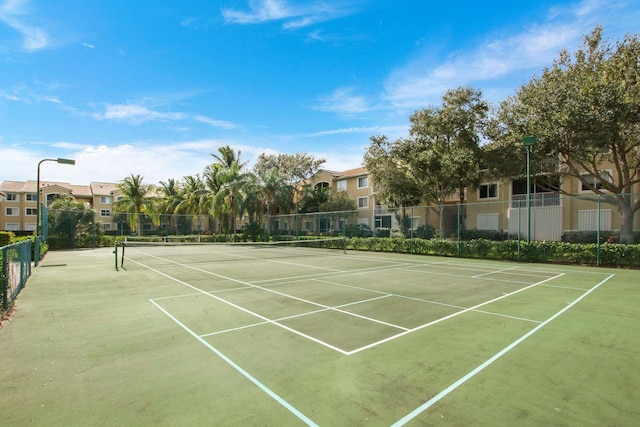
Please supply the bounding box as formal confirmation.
[392,274,615,427]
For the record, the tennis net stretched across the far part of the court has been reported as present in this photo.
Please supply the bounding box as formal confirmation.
[114,236,346,268]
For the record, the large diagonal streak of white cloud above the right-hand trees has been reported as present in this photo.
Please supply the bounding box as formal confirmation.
[383,0,619,109]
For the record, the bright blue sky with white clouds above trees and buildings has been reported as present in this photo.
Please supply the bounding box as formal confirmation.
[0,0,640,184]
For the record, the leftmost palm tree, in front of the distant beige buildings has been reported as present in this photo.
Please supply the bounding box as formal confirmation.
[113,174,154,235]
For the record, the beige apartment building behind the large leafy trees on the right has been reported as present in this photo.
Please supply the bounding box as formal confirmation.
[304,164,640,241]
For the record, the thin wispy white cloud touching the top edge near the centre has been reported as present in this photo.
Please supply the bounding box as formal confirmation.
[222,0,355,30]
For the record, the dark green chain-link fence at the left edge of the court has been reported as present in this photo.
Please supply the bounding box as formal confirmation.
[0,240,31,313]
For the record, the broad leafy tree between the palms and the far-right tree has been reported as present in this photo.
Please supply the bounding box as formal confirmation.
[364,87,489,234]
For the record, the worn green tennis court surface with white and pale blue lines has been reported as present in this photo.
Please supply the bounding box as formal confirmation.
[0,245,640,426]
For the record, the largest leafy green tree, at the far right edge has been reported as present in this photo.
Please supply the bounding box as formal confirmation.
[487,27,640,242]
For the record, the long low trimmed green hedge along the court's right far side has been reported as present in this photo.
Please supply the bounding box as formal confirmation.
[347,237,640,268]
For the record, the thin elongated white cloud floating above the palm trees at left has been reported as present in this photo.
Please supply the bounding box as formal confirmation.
[91,104,238,129]
